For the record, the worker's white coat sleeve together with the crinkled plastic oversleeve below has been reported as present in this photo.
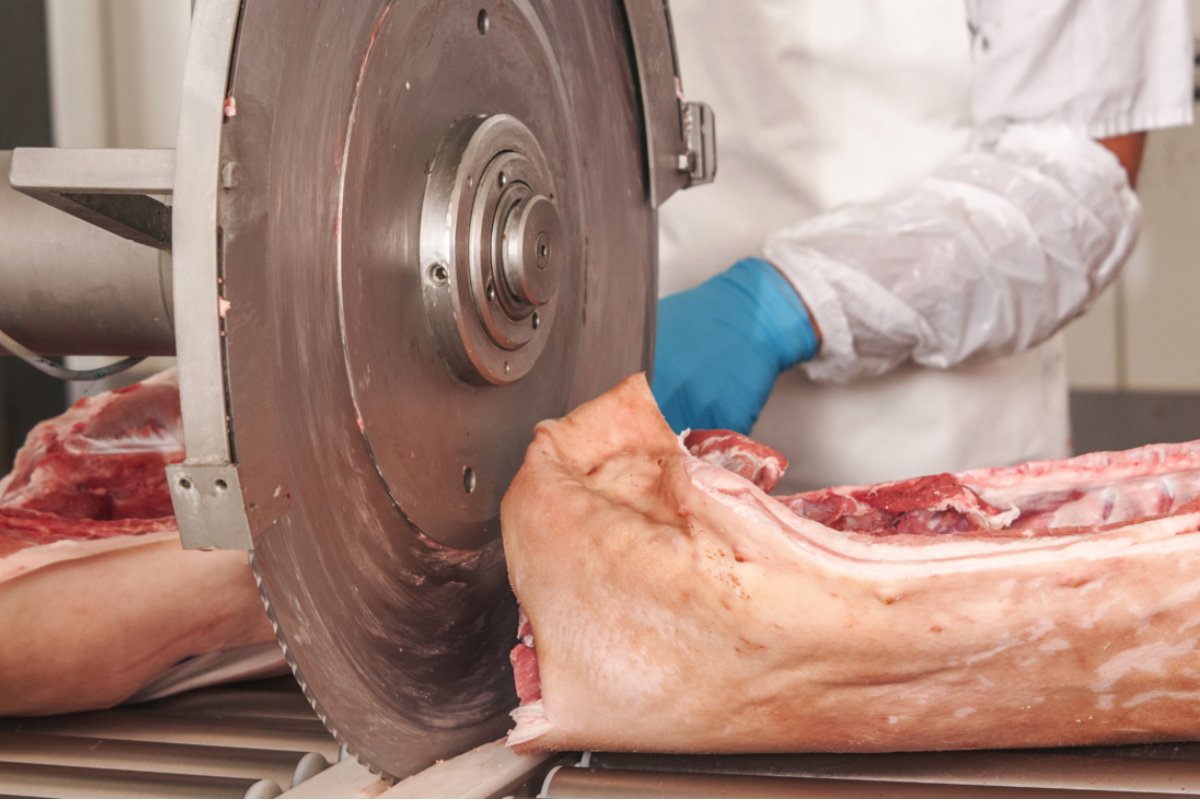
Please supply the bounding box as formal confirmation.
[766,0,1193,381]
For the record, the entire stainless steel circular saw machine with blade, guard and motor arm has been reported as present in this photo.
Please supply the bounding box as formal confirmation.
[0,0,715,777]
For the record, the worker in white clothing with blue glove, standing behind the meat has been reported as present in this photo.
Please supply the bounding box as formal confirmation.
[653,0,1193,490]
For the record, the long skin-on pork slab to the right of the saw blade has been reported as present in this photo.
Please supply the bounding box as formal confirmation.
[502,377,1200,752]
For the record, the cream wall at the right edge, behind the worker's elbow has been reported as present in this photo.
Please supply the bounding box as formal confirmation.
[1067,14,1200,392]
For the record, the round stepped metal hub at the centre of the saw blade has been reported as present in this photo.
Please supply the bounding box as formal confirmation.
[421,114,561,385]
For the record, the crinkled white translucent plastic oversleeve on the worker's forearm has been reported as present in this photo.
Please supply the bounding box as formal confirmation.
[766,124,1140,383]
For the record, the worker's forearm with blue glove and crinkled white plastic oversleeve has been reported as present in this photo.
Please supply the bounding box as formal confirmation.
[653,128,1145,433]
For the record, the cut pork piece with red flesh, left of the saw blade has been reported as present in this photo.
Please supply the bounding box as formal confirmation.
[0,373,283,715]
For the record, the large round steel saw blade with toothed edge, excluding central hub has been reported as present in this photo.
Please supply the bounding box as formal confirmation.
[218,0,656,777]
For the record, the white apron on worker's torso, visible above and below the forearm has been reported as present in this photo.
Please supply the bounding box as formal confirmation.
[660,0,1069,490]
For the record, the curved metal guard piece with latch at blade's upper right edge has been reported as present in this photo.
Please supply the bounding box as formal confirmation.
[624,0,716,209]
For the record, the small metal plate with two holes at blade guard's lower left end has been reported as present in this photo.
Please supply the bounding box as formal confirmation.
[167,464,252,550]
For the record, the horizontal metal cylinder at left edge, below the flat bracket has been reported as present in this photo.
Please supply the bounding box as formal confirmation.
[0,150,175,356]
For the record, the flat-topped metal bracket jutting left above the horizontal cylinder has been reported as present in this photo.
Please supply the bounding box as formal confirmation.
[8,147,175,251]
